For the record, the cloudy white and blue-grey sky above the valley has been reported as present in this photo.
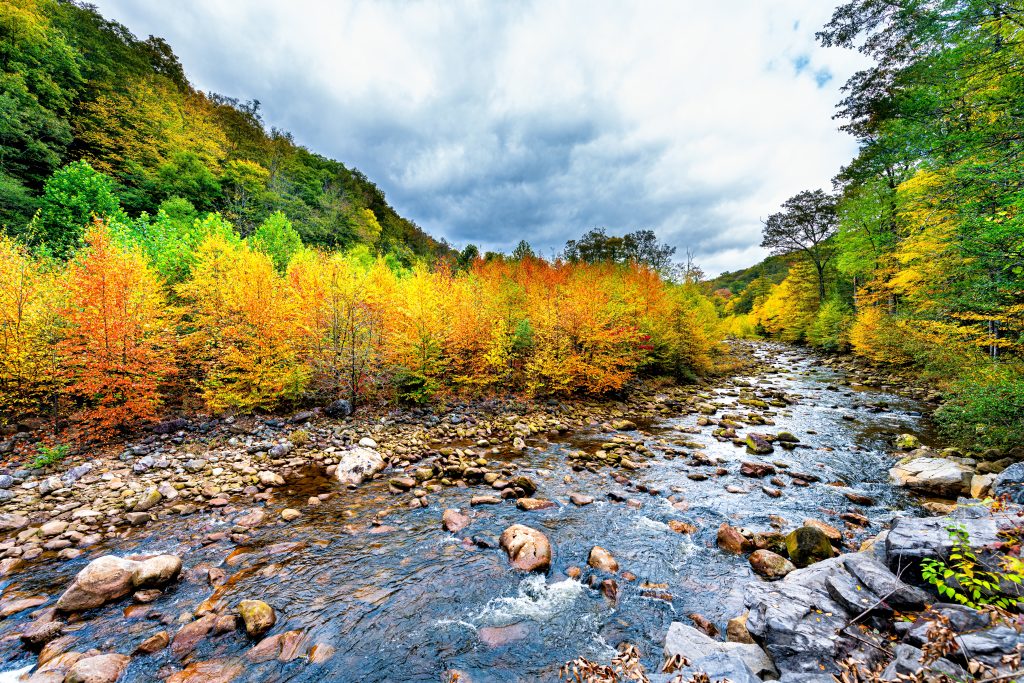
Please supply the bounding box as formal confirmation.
[94,0,863,273]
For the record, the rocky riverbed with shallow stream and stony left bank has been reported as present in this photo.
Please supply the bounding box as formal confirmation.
[0,344,1008,683]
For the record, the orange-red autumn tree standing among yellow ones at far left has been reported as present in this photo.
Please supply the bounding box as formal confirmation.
[61,220,175,434]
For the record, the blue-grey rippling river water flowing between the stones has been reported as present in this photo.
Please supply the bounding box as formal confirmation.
[0,344,929,683]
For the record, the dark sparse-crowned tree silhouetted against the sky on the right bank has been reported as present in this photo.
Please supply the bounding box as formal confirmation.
[761,189,837,301]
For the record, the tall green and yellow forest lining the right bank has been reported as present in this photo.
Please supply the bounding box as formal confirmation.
[711,0,1024,454]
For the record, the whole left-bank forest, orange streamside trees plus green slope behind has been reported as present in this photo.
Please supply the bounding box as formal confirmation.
[0,0,721,437]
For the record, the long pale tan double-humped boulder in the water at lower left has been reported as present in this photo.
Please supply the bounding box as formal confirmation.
[56,555,181,611]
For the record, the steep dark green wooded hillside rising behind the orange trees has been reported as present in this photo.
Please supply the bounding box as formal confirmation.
[0,0,447,262]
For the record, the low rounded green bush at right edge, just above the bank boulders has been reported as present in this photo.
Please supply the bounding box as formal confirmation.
[935,365,1024,447]
